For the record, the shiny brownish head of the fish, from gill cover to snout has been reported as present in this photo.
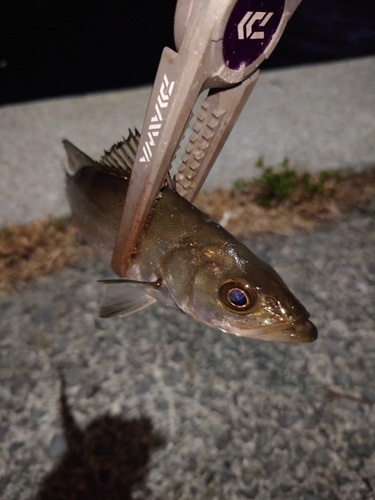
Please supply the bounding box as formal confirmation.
[163,240,317,344]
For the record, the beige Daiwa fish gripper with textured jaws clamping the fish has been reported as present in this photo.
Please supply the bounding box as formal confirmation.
[112,0,301,276]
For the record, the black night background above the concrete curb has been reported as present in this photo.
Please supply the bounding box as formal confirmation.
[0,0,375,104]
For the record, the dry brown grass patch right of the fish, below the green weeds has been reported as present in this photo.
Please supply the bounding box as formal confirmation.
[196,168,375,236]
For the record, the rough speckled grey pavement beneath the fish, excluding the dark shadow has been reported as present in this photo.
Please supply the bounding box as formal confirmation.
[0,213,375,500]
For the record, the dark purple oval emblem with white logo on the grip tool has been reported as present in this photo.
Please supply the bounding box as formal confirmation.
[223,0,285,69]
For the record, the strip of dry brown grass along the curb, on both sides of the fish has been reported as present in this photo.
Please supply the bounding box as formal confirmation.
[0,169,375,292]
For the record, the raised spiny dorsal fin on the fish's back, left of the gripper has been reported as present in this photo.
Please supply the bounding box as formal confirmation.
[100,129,140,172]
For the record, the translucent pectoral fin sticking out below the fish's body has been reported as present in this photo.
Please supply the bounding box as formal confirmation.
[99,279,159,318]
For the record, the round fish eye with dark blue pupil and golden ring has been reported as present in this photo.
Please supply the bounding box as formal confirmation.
[219,280,256,314]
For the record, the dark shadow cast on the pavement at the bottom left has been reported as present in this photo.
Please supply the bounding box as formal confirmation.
[36,376,163,500]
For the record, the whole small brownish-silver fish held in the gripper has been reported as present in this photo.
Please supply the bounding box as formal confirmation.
[63,129,317,344]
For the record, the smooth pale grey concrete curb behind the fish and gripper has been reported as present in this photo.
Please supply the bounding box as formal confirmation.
[0,57,375,225]
